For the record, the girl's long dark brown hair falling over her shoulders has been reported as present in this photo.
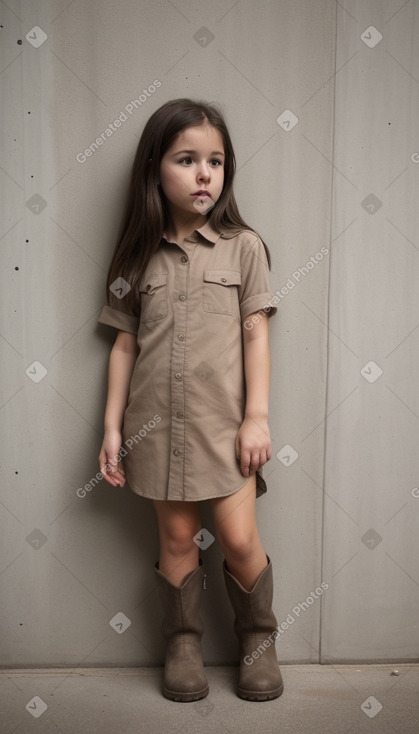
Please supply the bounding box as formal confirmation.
[106,98,271,313]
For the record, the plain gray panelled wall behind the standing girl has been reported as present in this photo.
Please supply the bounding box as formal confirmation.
[0,0,419,667]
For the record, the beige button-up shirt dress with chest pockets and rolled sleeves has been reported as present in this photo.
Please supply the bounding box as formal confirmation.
[99,221,277,501]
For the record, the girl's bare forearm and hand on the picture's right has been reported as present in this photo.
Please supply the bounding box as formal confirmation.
[236,312,272,477]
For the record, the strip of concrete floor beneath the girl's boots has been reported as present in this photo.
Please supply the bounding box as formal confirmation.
[0,664,419,734]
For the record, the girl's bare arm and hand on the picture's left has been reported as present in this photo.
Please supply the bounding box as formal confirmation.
[99,331,138,487]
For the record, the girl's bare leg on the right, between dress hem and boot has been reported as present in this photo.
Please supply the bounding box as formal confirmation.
[210,474,268,591]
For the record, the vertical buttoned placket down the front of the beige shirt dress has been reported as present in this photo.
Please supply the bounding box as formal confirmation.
[167,253,189,499]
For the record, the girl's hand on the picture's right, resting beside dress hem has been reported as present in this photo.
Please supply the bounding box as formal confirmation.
[236,417,272,477]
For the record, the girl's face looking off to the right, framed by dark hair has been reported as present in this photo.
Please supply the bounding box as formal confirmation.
[160,123,225,219]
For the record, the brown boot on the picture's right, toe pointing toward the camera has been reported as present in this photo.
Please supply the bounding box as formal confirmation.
[223,556,284,701]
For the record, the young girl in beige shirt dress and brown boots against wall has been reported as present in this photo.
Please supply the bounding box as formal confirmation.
[99,99,283,701]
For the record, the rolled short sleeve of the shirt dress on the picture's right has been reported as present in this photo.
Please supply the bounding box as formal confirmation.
[239,237,278,320]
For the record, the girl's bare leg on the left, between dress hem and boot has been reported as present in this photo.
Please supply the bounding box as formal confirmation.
[154,500,201,586]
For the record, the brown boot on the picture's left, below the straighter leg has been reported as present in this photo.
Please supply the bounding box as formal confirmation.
[154,558,209,701]
